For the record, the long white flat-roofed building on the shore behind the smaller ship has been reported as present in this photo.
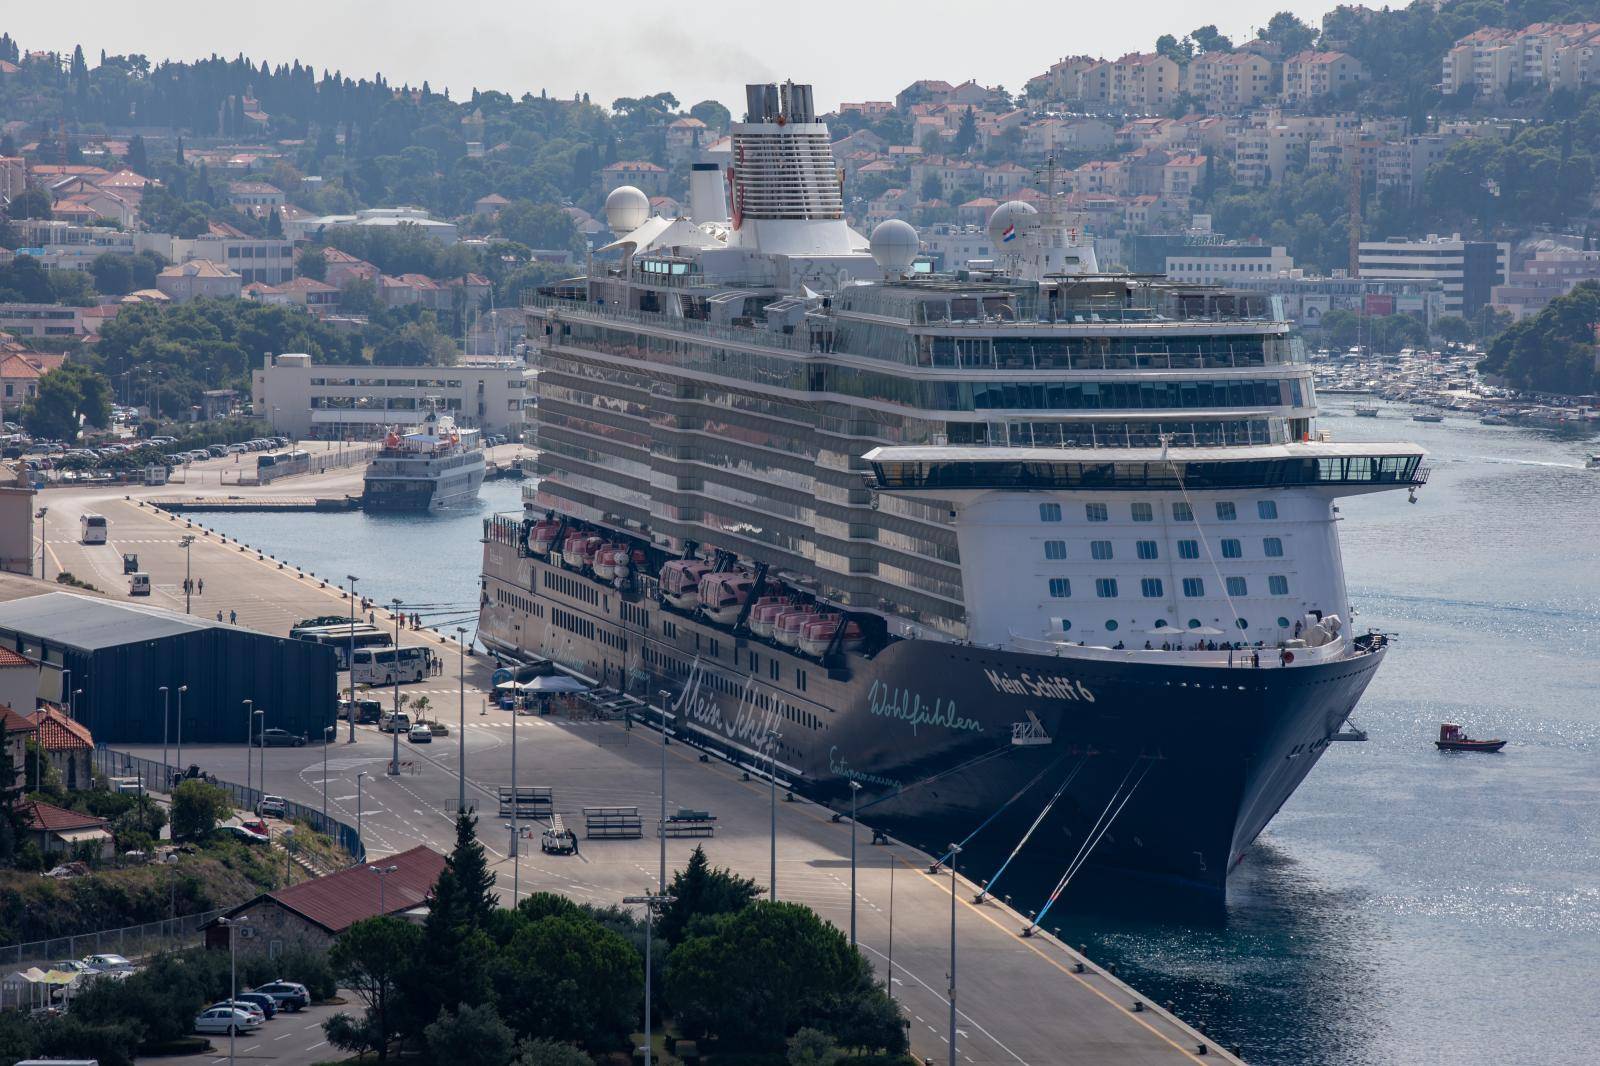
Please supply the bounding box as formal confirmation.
[251,352,533,440]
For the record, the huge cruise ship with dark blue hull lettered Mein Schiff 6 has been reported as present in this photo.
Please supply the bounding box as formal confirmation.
[478,83,1426,892]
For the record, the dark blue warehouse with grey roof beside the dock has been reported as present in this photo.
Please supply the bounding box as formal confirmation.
[0,592,336,744]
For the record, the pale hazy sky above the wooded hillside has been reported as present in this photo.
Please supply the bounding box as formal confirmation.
[0,0,1334,114]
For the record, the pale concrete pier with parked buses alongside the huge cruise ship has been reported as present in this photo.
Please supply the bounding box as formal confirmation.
[38,451,1238,1066]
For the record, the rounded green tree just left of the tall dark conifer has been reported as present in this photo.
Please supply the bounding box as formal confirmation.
[325,916,425,1063]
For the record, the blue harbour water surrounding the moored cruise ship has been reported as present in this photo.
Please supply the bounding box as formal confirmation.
[208,416,1600,1066]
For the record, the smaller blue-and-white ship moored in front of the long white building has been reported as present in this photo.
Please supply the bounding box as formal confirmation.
[362,411,485,514]
